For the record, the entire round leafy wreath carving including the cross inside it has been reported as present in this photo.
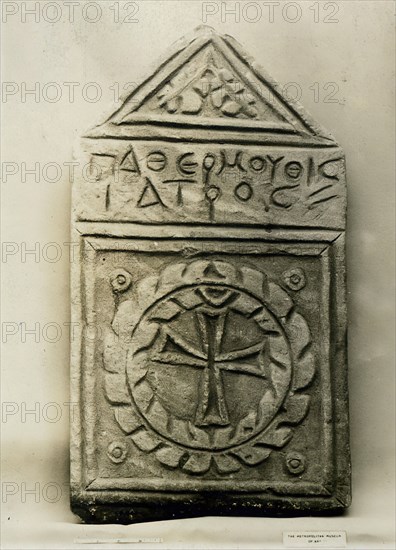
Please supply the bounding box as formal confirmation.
[104,259,315,474]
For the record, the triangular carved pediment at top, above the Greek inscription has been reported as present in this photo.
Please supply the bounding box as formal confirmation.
[94,27,334,144]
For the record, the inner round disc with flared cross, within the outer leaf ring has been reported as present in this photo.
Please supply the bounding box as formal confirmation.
[127,280,291,450]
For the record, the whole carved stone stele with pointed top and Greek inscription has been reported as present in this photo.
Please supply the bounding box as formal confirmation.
[71,27,350,523]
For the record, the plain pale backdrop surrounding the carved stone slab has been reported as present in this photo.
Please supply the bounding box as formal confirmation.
[1,0,395,549]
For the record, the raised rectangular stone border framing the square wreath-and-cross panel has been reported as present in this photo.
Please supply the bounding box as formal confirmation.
[71,223,351,523]
